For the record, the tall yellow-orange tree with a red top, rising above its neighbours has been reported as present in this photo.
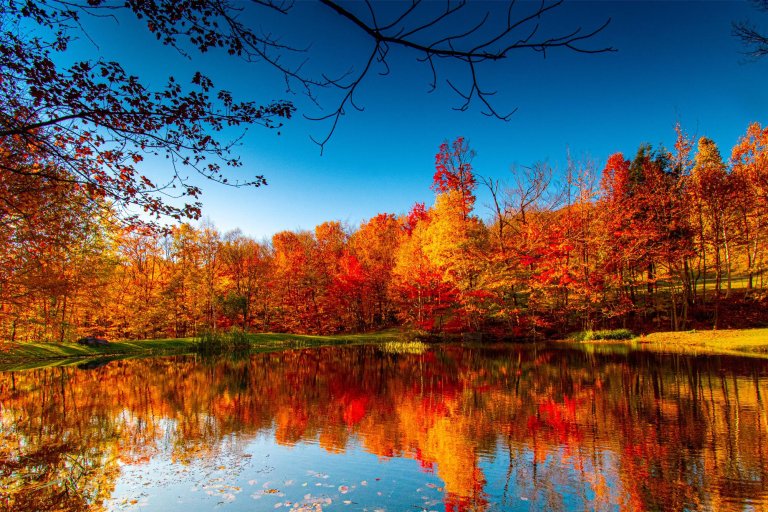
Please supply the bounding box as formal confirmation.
[394,137,486,331]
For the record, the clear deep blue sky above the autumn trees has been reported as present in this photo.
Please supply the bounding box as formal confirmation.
[70,1,768,239]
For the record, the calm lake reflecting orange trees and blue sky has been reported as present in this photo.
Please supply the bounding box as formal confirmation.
[0,344,768,512]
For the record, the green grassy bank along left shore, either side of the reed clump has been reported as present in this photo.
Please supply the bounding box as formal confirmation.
[0,330,401,370]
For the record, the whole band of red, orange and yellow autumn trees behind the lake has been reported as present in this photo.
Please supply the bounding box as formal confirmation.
[0,124,768,341]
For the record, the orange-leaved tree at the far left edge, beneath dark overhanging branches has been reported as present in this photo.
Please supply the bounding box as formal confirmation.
[0,141,113,341]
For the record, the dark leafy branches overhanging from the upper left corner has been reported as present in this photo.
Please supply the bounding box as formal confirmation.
[0,1,293,219]
